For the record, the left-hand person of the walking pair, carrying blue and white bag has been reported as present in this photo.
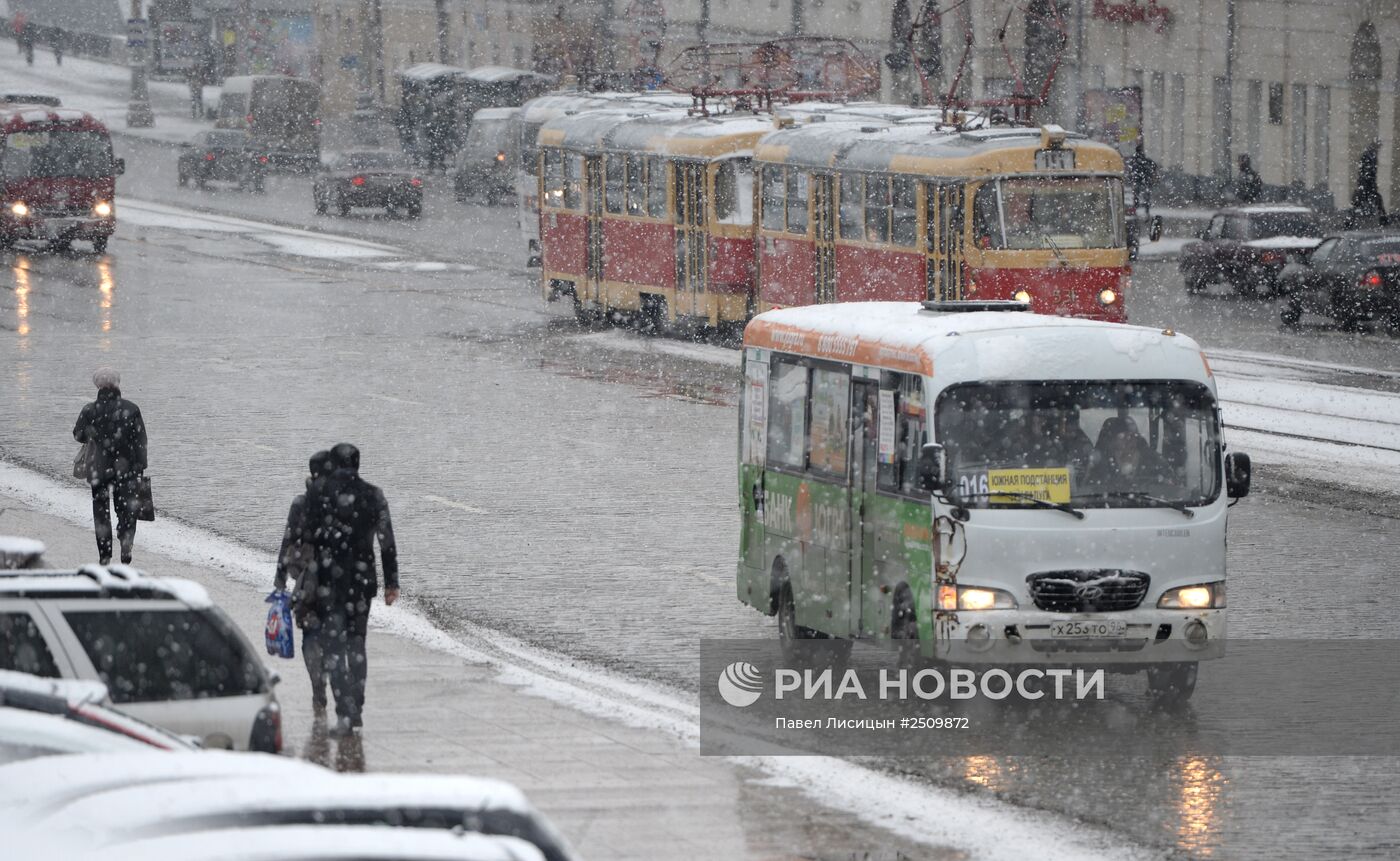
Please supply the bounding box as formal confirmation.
[273,451,335,720]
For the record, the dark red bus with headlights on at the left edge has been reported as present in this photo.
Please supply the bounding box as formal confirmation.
[0,102,126,253]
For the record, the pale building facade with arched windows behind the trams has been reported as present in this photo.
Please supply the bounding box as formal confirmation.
[315,0,1400,207]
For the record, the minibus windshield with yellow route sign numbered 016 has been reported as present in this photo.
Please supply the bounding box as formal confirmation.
[935,381,1221,508]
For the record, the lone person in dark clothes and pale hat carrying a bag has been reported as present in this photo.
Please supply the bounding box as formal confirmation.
[73,368,146,566]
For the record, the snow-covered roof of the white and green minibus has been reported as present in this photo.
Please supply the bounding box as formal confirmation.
[743,302,1210,381]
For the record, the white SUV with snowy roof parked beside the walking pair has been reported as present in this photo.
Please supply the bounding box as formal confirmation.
[0,566,281,753]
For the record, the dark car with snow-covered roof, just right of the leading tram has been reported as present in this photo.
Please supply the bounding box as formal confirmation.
[1177,203,1322,295]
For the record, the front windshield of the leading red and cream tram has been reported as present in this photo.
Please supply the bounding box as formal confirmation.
[973,176,1123,251]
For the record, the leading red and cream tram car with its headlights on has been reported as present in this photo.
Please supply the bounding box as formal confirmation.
[755,119,1130,322]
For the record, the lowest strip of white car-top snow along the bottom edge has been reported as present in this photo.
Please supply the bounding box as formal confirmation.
[102,825,543,861]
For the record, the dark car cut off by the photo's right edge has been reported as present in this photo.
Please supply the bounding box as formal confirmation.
[1278,230,1400,332]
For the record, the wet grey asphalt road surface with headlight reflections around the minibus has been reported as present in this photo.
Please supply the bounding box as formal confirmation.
[0,177,1400,858]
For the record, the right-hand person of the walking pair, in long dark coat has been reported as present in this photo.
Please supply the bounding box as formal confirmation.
[307,442,399,736]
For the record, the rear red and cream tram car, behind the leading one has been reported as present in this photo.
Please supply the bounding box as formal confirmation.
[539,109,774,326]
